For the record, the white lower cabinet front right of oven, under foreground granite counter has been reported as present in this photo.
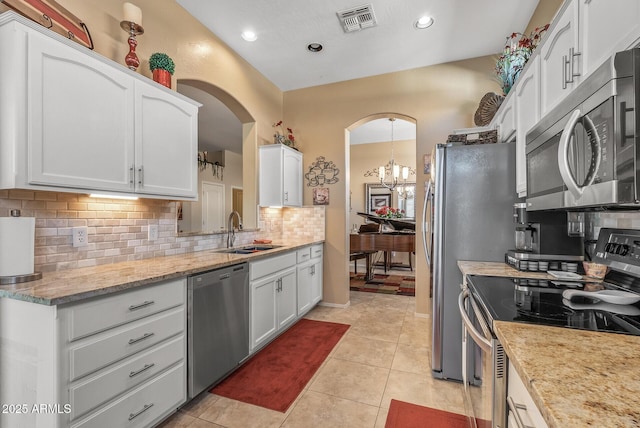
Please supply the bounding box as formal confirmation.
[507,362,547,428]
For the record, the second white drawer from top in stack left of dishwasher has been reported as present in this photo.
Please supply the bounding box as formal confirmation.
[69,307,186,381]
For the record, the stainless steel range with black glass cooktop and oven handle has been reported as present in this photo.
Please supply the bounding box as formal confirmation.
[459,229,640,428]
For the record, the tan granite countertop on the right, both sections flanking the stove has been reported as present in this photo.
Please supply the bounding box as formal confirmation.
[458,261,640,428]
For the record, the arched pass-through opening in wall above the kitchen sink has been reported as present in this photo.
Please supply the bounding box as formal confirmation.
[177,79,258,234]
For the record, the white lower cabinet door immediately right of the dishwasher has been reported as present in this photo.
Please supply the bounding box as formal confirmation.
[251,275,279,351]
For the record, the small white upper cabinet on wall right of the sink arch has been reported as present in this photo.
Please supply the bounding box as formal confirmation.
[258,144,302,207]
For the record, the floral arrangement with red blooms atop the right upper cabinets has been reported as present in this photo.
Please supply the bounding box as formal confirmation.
[495,24,549,96]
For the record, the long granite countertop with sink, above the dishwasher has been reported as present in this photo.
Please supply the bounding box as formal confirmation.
[0,240,324,305]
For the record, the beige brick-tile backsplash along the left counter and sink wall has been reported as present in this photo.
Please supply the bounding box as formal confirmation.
[0,190,325,272]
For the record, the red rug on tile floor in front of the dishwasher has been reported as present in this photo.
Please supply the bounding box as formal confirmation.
[210,318,349,412]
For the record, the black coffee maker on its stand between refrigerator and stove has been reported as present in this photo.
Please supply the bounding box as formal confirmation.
[505,203,584,272]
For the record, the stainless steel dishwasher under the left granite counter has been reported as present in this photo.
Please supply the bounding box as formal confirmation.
[187,263,249,398]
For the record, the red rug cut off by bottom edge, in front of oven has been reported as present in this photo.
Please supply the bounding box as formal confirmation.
[384,400,491,428]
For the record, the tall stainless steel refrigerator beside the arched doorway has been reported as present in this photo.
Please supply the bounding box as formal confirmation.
[431,142,518,381]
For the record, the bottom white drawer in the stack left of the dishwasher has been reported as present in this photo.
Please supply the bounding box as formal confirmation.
[71,363,187,428]
